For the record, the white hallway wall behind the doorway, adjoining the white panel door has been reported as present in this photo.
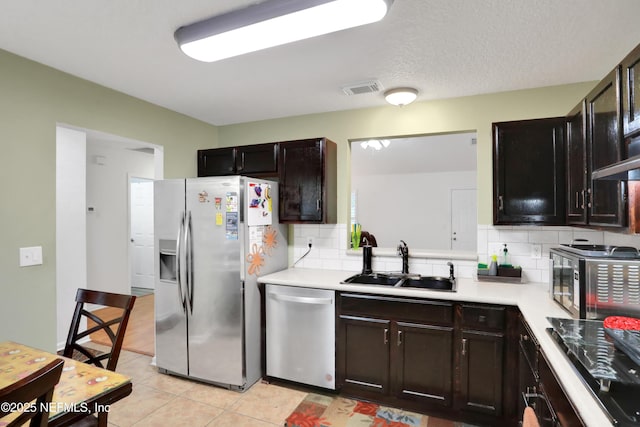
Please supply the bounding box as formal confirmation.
[86,139,155,294]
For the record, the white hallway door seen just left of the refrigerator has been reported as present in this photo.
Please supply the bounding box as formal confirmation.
[129,177,154,289]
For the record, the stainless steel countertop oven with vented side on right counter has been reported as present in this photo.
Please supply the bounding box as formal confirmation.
[549,244,640,319]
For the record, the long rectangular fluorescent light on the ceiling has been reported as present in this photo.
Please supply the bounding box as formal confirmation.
[174,0,393,62]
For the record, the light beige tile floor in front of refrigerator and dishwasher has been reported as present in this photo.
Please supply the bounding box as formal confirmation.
[104,351,307,427]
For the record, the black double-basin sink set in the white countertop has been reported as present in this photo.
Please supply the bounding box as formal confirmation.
[342,273,456,292]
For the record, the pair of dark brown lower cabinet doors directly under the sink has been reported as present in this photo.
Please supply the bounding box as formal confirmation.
[340,315,453,405]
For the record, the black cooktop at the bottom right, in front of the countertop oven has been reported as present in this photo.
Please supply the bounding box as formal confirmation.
[548,318,640,427]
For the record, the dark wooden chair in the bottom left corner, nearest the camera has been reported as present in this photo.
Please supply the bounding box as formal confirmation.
[0,359,64,427]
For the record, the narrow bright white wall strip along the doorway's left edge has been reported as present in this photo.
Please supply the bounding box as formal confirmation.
[56,126,87,349]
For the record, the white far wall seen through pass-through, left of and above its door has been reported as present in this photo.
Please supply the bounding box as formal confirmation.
[351,171,477,249]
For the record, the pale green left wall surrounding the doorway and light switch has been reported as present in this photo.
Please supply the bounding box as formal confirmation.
[0,50,218,351]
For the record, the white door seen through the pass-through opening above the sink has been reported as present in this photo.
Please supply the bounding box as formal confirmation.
[451,189,478,251]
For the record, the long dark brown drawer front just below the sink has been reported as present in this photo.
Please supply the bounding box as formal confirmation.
[340,293,453,325]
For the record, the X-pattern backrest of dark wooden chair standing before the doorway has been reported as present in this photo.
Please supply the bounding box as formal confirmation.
[63,289,136,371]
